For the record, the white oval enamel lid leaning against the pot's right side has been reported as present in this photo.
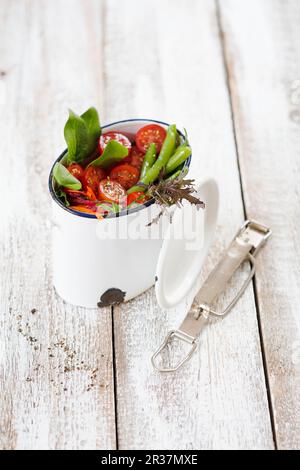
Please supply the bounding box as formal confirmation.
[155,179,219,308]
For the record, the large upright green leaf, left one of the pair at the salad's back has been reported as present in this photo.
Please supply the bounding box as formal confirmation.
[64,110,89,163]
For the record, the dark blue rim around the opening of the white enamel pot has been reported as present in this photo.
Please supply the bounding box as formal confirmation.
[48,118,192,219]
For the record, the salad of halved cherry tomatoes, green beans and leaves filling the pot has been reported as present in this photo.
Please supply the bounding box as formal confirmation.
[52,108,204,219]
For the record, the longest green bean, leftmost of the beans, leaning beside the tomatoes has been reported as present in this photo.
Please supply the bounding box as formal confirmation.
[141,124,177,185]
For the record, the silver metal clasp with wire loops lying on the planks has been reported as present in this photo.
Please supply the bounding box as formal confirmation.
[151,220,272,372]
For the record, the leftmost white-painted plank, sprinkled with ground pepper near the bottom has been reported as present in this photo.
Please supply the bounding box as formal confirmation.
[0,0,115,449]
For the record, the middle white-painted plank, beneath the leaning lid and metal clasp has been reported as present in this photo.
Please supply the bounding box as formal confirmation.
[105,0,273,449]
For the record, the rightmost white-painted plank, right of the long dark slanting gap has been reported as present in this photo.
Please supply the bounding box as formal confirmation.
[220,0,300,449]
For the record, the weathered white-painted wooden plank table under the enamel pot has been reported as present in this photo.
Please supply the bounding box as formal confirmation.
[0,0,300,449]
